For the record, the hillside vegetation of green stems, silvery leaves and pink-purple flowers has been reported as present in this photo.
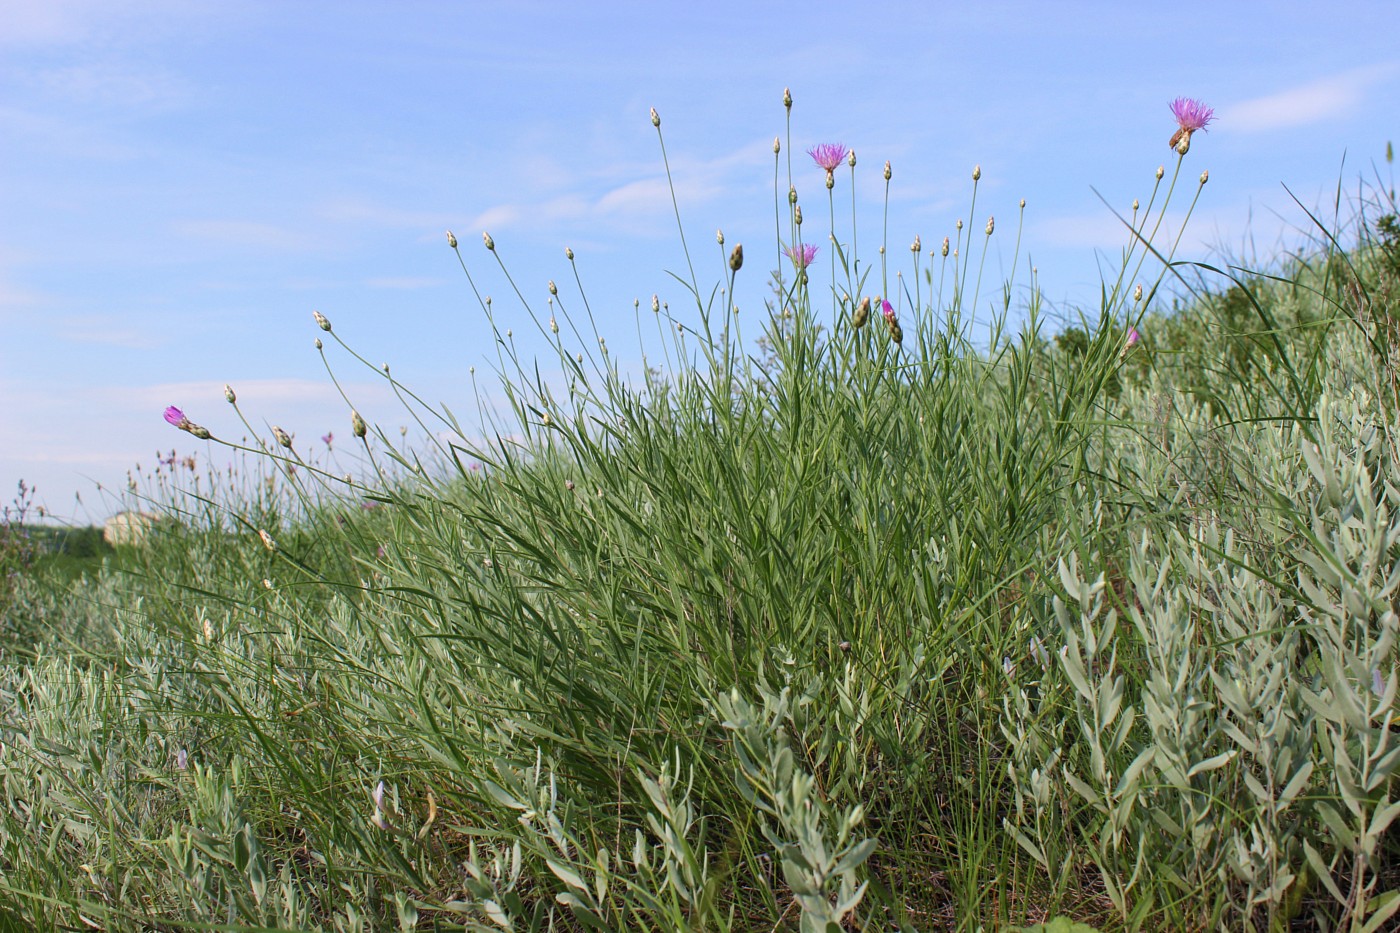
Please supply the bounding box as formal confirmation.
[0,94,1400,932]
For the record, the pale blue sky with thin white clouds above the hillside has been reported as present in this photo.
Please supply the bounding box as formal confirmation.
[0,0,1400,523]
